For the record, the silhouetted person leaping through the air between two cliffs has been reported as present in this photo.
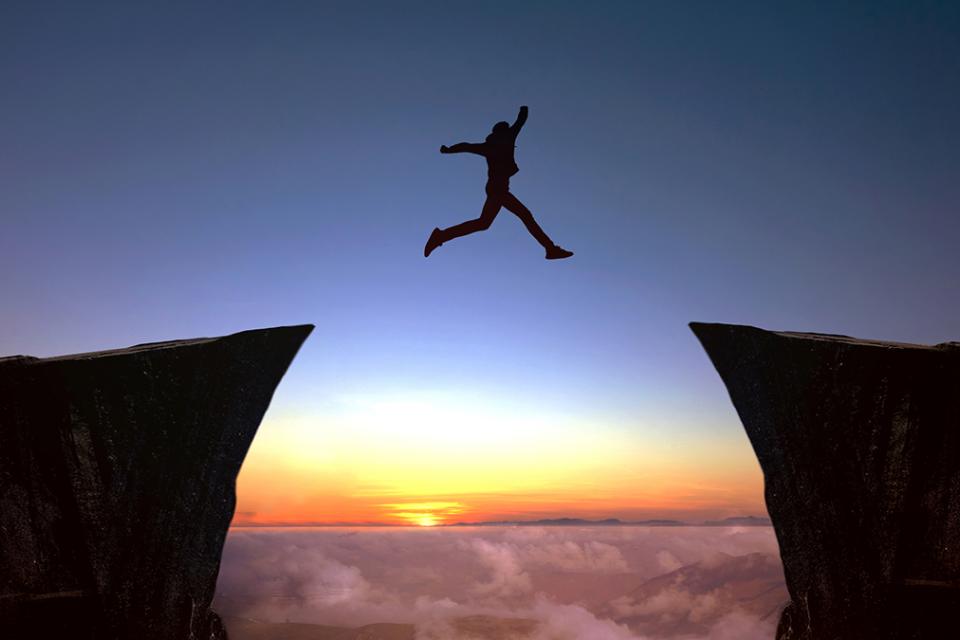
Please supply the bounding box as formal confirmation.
[423,106,573,260]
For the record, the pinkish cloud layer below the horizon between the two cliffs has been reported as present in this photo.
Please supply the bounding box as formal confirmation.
[215,527,787,640]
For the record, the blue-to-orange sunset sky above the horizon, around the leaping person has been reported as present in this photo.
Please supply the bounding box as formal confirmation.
[0,1,960,524]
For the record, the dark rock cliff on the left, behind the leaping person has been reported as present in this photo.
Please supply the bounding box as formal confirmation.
[0,326,313,640]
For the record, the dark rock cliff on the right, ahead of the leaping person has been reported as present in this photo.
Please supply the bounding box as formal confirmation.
[691,323,960,640]
